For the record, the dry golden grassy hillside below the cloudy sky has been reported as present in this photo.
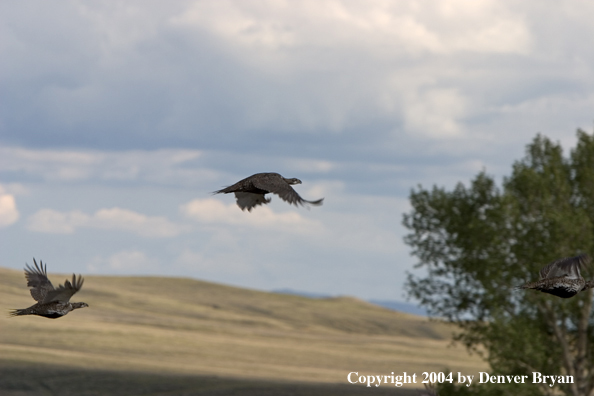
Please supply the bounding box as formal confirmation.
[0,268,486,394]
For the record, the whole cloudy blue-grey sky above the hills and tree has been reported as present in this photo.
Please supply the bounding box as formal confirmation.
[0,0,594,300]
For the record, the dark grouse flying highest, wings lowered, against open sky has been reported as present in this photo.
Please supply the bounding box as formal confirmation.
[213,173,324,212]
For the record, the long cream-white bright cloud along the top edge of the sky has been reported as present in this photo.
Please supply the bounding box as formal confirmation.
[170,0,531,55]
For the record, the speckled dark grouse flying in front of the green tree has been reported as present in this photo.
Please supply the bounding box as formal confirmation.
[519,254,594,298]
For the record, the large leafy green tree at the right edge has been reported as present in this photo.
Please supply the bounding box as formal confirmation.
[403,130,594,396]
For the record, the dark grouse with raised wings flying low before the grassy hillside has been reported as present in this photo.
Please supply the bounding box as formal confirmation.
[10,259,88,319]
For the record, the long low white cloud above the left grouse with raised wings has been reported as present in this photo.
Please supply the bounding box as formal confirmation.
[27,208,188,238]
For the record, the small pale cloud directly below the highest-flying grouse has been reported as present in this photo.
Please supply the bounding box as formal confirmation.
[180,198,322,232]
